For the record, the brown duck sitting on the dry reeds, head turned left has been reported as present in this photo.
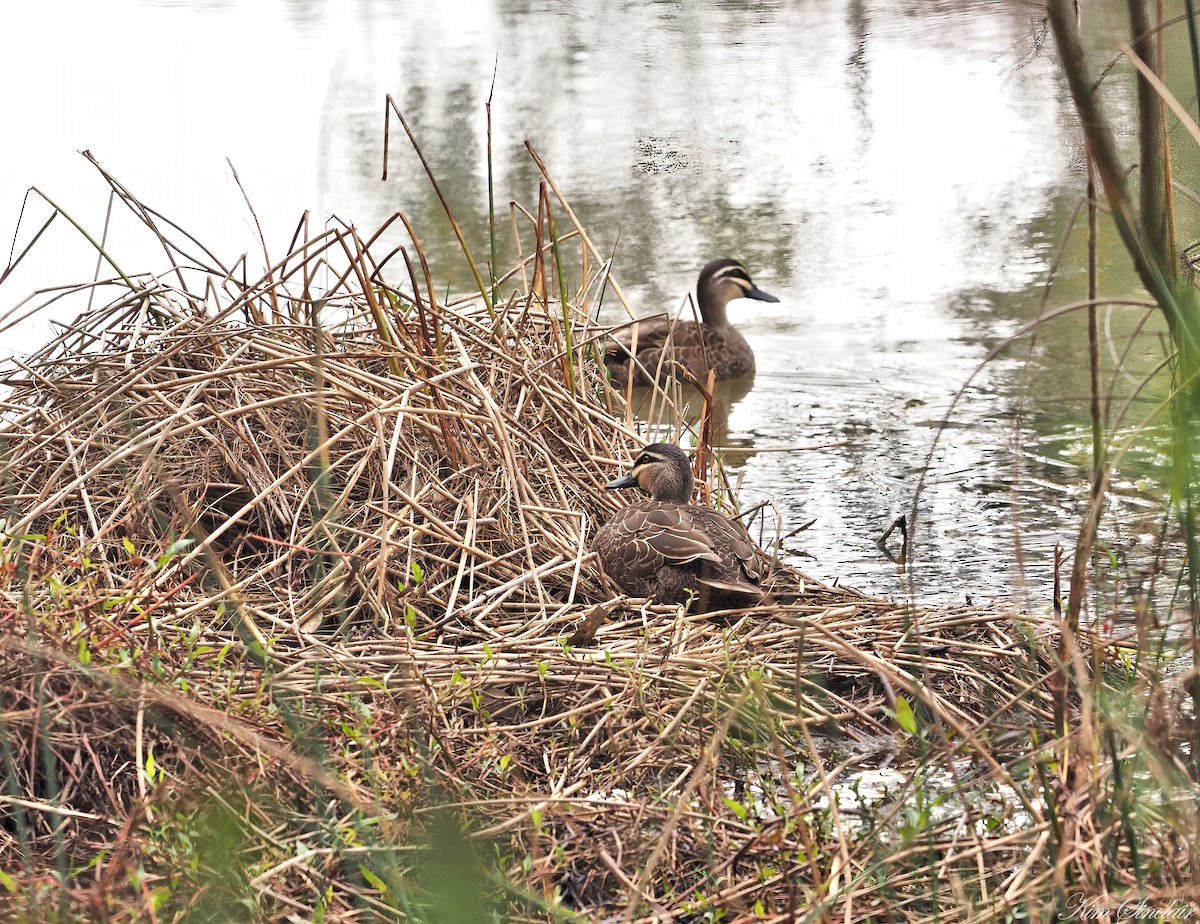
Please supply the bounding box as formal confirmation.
[592,443,764,613]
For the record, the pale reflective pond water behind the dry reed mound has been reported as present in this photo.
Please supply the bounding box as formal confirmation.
[0,0,1187,607]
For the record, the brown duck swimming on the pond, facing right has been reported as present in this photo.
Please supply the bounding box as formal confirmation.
[604,259,779,388]
